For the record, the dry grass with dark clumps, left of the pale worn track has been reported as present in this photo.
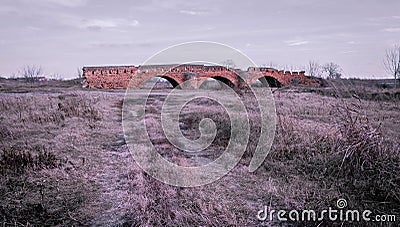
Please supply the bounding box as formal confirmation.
[0,93,101,226]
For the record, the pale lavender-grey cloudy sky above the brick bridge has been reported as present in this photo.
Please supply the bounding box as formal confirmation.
[0,0,400,78]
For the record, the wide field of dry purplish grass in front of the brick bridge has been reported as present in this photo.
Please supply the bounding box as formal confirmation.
[0,79,400,226]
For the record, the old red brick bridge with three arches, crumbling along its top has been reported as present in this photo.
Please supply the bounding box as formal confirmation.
[83,64,316,89]
